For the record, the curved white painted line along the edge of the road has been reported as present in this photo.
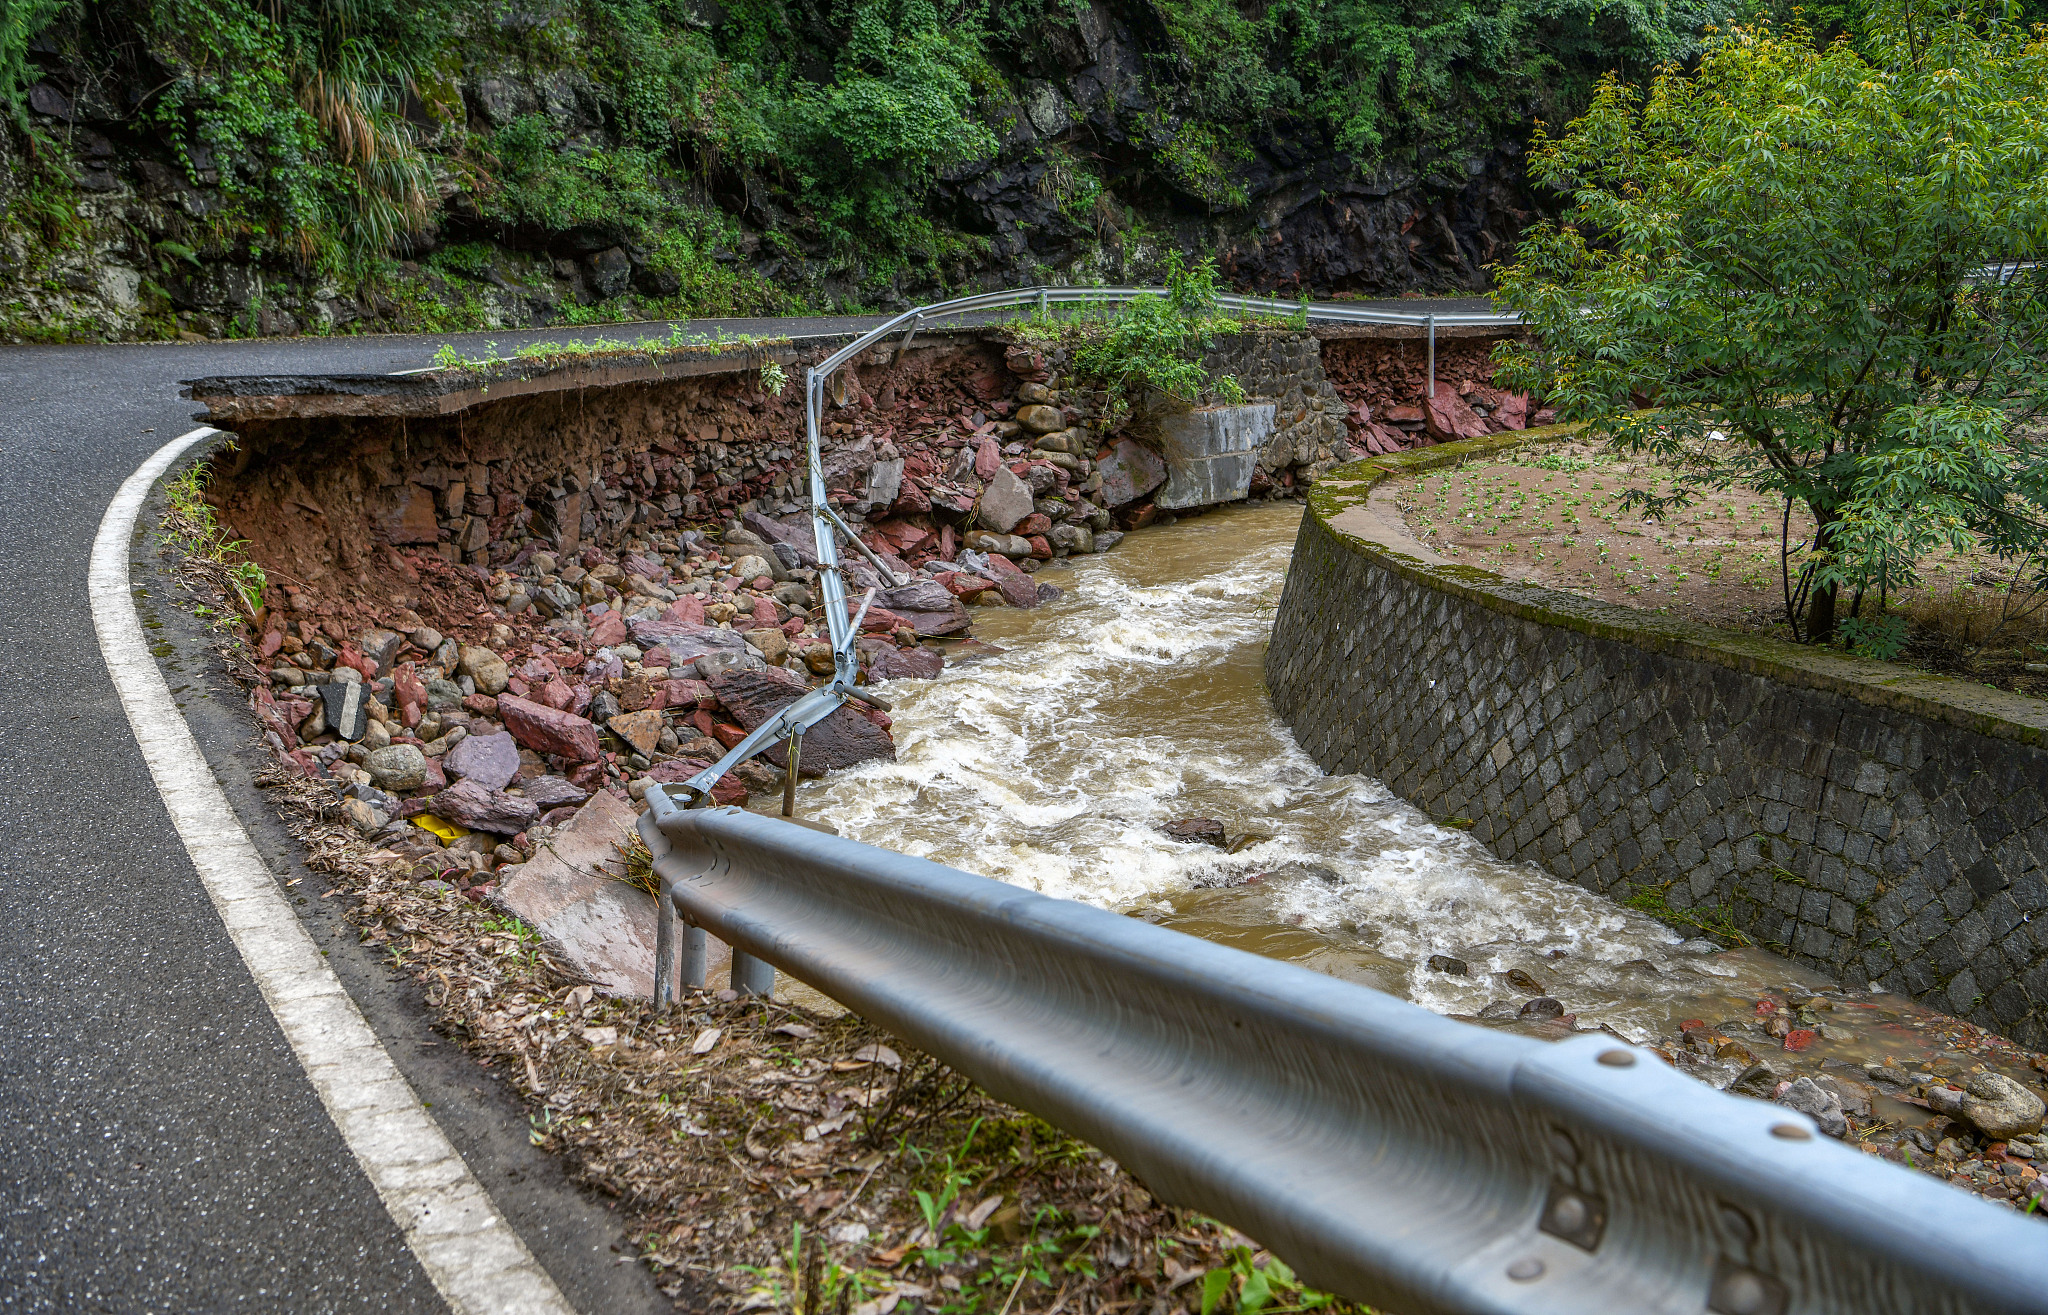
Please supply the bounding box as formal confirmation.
[86,428,575,1315]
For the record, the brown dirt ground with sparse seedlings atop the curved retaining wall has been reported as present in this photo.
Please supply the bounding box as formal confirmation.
[1395,442,2048,696]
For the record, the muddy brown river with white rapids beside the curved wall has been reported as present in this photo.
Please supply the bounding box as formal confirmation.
[782,495,2031,1114]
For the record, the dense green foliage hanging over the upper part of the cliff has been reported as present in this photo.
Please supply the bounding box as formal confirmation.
[0,0,1735,311]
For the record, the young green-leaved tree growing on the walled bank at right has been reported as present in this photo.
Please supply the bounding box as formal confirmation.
[1497,0,2048,641]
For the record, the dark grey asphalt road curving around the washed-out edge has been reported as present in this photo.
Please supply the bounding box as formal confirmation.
[0,301,1483,1311]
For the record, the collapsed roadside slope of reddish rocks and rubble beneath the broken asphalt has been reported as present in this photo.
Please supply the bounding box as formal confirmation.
[224,331,1335,897]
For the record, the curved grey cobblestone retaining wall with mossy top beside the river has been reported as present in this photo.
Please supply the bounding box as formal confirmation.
[1266,440,2048,1047]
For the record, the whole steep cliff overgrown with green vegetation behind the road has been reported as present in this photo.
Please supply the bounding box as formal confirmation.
[0,0,1733,336]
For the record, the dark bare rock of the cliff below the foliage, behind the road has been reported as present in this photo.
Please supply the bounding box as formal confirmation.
[0,0,1536,340]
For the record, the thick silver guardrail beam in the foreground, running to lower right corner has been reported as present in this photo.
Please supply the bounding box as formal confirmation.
[639,791,2048,1315]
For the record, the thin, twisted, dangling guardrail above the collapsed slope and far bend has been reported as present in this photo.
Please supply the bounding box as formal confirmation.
[682,287,1522,813]
